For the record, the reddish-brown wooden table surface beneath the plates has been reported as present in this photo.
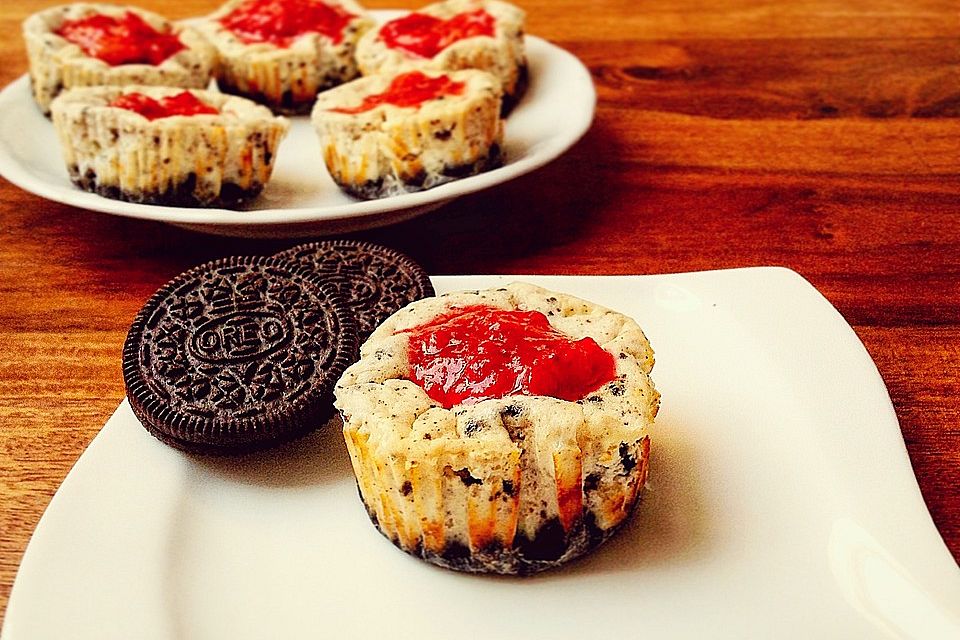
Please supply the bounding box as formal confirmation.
[0,0,960,624]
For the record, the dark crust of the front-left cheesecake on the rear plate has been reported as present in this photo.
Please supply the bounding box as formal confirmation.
[68,166,263,207]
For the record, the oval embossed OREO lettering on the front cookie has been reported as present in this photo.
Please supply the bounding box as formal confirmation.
[189,311,293,364]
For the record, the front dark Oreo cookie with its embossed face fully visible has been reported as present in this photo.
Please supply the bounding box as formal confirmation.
[123,257,358,454]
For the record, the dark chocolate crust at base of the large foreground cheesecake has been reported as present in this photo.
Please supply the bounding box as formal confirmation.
[360,493,641,576]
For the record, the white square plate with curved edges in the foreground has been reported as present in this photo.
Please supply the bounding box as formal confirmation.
[3,268,960,640]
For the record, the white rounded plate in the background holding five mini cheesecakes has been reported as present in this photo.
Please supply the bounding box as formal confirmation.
[0,18,596,237]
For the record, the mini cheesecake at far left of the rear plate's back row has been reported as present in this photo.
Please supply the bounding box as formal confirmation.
[23,3,216,114]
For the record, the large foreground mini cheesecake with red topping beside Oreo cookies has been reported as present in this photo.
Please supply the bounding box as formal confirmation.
[335,283,659,575]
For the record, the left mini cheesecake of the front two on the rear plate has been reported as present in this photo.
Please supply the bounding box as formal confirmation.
[52,86,289,207]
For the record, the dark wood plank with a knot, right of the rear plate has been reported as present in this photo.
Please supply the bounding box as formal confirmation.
[580,37,960,120]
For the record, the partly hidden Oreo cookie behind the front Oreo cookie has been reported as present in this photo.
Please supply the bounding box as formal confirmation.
[274,240,436,342]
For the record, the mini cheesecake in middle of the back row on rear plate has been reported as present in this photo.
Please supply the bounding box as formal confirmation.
[197,0,373,114]
